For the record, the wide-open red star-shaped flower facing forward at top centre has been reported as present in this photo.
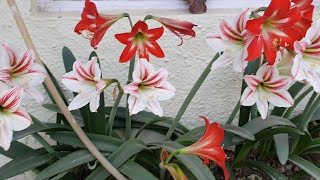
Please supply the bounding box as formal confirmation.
[115,21,164,63]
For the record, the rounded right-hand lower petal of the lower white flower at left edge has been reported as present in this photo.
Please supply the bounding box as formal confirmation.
[7,109,32,131]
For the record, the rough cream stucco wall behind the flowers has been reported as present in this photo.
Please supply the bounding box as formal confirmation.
[0,0,318,179]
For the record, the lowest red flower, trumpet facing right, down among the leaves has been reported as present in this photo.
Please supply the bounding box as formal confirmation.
[177,116,229,179]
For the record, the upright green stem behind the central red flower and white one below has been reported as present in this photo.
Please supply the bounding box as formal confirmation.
[125,15,135,139]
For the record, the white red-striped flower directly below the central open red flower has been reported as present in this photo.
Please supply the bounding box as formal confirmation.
[123,59,176,116]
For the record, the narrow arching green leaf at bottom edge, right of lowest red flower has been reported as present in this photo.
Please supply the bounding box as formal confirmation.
[237,161,288,180]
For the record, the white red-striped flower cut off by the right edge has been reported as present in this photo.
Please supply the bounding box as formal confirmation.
[291,20,320,93]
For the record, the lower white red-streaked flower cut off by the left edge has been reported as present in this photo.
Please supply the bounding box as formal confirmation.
[0,87,32,151]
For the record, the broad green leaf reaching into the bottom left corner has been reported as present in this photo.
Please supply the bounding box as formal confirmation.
[0,152,62,179]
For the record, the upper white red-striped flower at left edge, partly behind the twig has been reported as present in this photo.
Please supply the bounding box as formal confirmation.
[0,44,47,102]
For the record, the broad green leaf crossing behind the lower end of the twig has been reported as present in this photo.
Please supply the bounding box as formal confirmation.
[86,139,146,180]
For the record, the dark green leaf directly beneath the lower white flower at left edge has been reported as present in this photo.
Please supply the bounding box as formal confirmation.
[0,141,33,159]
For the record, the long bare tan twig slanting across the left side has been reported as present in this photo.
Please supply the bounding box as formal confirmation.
[7,0,126,180]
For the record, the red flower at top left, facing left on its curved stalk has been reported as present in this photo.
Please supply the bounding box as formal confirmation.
[74,0,124,48]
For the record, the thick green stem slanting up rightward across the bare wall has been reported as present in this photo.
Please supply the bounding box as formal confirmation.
[166,53,219,139]
